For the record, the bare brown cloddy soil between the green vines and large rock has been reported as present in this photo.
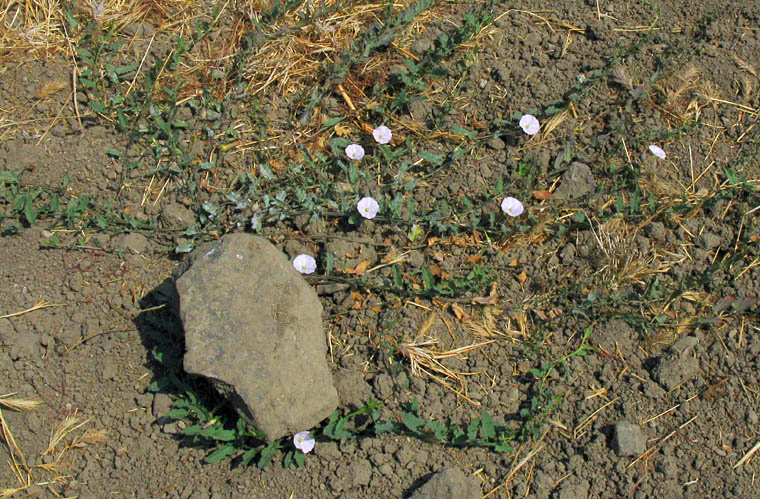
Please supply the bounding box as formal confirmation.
[0,1,760,498]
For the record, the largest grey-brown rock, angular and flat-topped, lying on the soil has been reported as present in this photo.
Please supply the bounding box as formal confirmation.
[176,233,338,439]
